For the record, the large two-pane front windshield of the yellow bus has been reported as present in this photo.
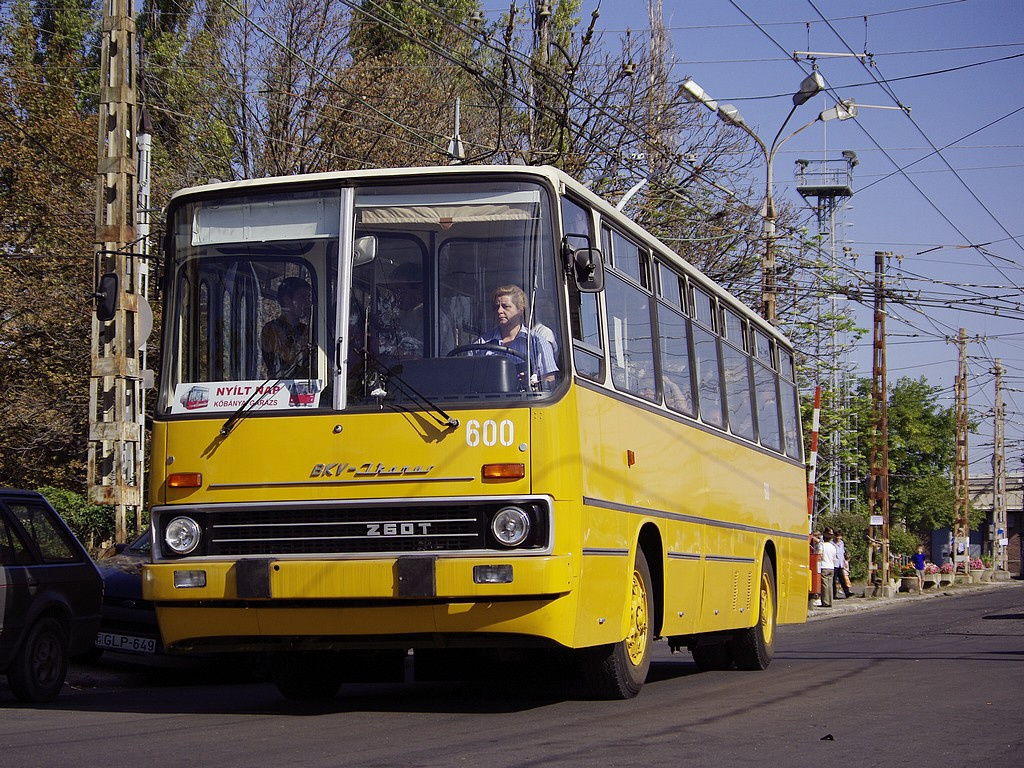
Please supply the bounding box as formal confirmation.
[161,180,565,415]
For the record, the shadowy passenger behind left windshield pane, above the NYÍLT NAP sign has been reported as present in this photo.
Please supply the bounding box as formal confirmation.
[260,278,313,379]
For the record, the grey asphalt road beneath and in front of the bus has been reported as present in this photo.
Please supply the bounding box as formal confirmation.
[0,582,1024,768]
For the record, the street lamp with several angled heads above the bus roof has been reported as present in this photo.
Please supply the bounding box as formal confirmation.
[679,70,857,325]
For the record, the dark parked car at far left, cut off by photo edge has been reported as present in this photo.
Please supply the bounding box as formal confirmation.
[0,488,103,702]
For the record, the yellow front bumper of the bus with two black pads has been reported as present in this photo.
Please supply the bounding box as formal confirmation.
[143,555,574,650]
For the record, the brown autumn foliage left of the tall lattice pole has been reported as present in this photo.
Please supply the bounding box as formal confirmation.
[0,0,98,488]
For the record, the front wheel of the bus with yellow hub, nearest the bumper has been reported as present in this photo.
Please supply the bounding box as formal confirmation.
[581,549,654,698]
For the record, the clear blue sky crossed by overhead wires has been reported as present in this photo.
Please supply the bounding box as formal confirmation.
[582,0,1024,475]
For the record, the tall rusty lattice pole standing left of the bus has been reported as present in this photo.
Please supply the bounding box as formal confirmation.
[88,0,142,543]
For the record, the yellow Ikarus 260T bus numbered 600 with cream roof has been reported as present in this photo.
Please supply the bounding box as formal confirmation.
[144,166,808,698]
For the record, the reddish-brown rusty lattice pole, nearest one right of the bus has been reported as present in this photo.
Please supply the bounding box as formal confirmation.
[867,251,890,597]
